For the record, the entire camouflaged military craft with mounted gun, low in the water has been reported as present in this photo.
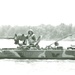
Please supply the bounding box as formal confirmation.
[0,32,75,59]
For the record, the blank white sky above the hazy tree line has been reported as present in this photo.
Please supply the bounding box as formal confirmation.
[0,0,75,26]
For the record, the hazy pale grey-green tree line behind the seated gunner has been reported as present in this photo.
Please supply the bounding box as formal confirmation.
[0,23,75,40]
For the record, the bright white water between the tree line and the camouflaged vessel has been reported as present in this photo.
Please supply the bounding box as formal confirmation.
[0,39,75,48]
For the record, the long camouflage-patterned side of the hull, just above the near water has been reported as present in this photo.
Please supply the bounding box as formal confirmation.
[0,49,75,59]
